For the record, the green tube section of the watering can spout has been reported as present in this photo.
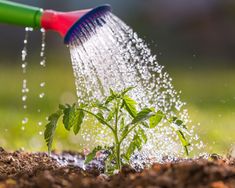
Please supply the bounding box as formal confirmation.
[0,0,43,28]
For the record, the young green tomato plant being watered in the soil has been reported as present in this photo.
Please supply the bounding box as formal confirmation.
[44,87,189,172]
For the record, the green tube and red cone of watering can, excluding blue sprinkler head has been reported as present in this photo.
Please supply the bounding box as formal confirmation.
[0,0,90,37]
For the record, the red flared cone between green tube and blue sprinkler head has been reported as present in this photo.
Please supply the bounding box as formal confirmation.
[41,9,91,37]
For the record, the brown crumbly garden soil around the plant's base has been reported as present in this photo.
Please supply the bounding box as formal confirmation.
[0,148,235,188]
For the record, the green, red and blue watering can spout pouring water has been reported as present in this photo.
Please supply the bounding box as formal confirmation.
[0,0,111,44]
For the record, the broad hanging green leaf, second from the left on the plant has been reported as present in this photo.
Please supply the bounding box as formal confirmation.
[63,105,77,131]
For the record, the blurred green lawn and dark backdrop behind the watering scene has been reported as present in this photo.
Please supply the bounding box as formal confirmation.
[0,0,235,154]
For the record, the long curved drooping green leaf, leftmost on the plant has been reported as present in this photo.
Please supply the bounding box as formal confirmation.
[44,110,62,154]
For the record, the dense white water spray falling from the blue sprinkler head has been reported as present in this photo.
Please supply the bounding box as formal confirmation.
[69,13,203,164]
